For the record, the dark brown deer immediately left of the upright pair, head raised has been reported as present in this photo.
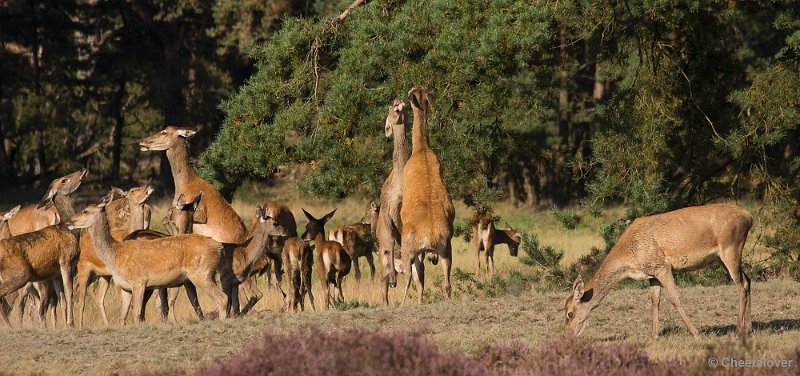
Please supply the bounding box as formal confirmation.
[328,202,380,280]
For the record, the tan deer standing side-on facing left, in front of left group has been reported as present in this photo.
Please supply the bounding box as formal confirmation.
[67,191,227,322]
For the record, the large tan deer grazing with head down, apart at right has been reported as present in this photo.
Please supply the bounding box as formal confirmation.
[564,204,753,338]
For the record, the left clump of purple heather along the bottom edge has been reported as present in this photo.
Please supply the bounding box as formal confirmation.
[197,330,488,376]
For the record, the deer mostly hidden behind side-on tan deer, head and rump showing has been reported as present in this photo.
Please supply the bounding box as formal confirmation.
[77,182,153,327]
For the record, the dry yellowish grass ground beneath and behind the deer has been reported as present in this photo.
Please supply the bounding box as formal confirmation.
[0,184,800,374]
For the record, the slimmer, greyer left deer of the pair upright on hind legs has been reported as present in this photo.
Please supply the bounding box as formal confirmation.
[374,99,417,305]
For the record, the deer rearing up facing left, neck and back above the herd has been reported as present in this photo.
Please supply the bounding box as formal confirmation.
[139,126,247,244]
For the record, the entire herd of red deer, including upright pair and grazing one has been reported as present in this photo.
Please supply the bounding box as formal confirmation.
[0,87,753,337]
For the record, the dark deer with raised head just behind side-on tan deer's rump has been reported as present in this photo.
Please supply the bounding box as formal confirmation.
[219,205,287,316]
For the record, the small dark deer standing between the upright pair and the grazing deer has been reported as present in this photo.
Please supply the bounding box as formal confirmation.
[471,213,522,276]
